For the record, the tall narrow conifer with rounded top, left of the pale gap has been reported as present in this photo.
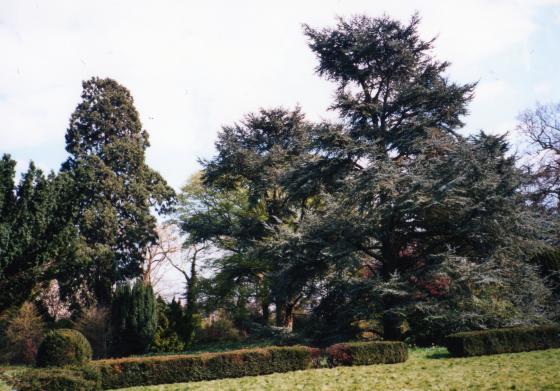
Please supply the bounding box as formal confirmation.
[60,78,174,305]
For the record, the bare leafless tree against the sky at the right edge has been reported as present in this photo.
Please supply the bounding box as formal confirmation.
[518,104,560,211]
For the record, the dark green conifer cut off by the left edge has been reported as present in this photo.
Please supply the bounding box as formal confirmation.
[0,155,76,311]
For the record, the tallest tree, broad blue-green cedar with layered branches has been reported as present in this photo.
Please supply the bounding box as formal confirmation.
[294,15,547,338]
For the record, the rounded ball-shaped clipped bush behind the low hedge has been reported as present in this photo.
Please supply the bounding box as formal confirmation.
[37,329,91,367]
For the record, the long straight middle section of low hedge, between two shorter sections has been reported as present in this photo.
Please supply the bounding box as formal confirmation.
[95,346,319,389]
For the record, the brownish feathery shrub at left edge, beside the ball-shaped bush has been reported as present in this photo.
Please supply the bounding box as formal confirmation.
[0,303,44,365]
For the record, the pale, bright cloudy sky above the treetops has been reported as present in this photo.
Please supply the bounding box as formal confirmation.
[0,0,560,189]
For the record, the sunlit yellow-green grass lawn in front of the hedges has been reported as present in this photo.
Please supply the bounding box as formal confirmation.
[114,348,560,391]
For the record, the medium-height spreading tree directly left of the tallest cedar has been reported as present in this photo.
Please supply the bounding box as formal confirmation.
[190,108,314,329]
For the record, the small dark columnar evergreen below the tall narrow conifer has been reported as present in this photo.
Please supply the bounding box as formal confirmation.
[111,280,157,356]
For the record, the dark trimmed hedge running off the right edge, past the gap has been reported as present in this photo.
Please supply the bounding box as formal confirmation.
[445,325,560,357]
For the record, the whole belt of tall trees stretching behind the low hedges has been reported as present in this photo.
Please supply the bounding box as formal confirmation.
[0,15,560,364]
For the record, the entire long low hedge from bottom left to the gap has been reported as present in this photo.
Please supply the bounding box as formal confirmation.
[8,342,408,391]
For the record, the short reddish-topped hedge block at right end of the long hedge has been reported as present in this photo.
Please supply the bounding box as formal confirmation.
[327,341,408,367]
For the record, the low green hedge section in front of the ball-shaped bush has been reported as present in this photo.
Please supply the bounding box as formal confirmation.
[14,366,101,391]
